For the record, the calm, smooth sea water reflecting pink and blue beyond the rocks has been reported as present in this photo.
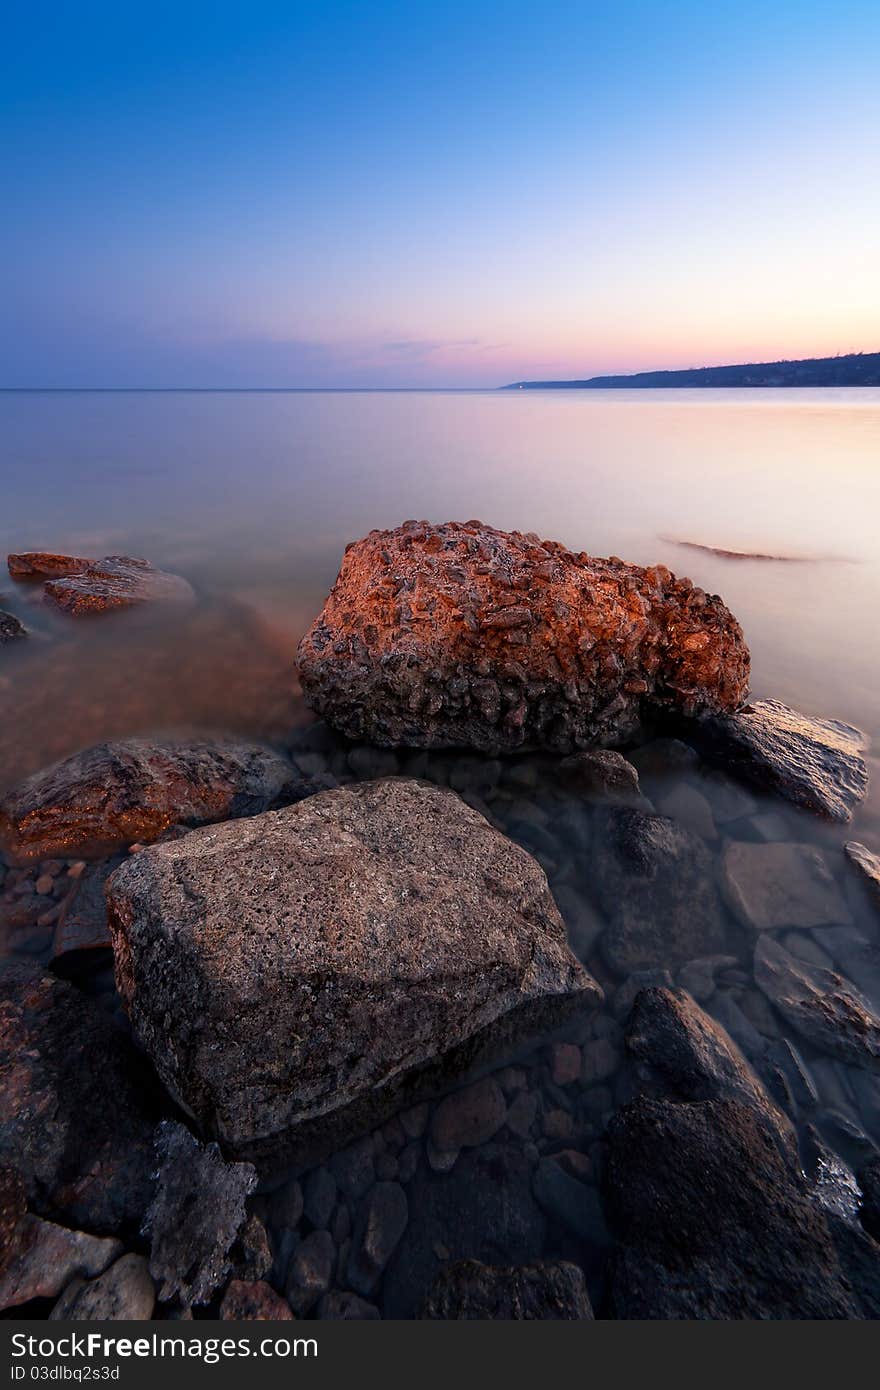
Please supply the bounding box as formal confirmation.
[0,389,880,811]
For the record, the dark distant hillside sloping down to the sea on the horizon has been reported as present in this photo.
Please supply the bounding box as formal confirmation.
[500,352,880,391]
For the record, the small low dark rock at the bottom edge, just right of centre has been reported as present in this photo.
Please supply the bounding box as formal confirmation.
[421,1259,592,1322]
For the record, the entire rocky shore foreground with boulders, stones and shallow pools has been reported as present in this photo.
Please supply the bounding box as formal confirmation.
[0,523,880,1319]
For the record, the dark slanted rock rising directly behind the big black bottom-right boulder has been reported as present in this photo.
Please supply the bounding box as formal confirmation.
[626,988,798,1162]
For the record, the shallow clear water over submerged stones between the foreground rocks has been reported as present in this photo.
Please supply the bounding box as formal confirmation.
[0,723,880,1318]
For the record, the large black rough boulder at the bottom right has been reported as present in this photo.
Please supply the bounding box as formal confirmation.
[605,1097,869,1319]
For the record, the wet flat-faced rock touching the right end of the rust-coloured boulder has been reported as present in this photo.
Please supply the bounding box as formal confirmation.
[687,699,867,821]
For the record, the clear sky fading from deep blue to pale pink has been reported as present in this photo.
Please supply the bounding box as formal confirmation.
[0,0,880,388]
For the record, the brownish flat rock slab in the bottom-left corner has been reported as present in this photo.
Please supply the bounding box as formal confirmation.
[0,1216,122,1308]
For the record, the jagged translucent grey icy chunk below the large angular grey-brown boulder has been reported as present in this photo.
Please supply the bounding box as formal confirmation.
[145,1120,257,1308]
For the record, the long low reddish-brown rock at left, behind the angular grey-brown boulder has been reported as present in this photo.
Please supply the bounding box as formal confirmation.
[0,737,303,863]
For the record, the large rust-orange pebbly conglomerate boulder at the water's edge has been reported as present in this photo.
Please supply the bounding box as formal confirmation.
[298,521,749,752]
